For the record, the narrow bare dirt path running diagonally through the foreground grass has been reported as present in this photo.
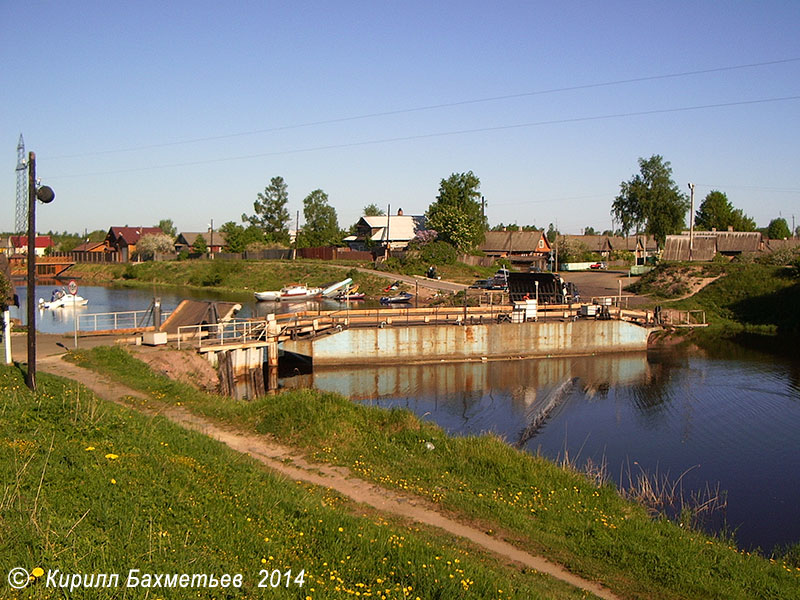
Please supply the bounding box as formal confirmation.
[39,356,618,600]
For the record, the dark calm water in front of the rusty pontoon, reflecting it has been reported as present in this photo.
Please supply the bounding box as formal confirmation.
[286,344,800,550]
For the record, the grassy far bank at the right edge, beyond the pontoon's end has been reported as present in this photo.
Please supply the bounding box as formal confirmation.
[631,263,800,334]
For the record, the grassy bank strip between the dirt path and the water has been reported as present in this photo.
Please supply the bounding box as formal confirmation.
[65,348,800,599]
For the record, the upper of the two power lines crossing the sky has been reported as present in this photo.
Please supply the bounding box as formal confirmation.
[48,57,800,160]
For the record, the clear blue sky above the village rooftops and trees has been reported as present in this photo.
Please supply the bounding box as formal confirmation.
[0,0,800,233]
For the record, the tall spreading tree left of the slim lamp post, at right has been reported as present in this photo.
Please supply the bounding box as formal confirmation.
[611,154,689,246]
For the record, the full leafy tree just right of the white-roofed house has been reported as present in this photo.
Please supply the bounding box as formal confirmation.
[425,171,487,250]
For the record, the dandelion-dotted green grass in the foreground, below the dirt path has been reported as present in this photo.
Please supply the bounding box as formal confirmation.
[0,367,585,600]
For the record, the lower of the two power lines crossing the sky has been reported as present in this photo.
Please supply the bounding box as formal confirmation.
[50,96,800,179]
